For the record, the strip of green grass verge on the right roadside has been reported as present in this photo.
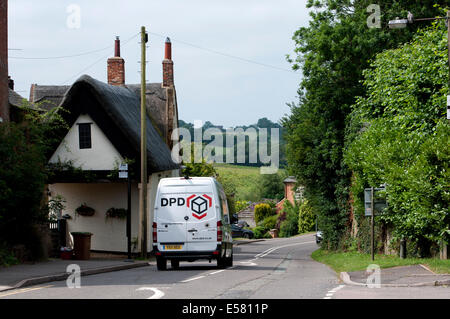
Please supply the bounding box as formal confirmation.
[311,249,450,274]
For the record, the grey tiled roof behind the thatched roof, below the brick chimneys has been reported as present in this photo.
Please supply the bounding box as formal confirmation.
[30,83,170,140]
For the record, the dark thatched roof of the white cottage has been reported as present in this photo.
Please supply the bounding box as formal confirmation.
[57,75,179,172]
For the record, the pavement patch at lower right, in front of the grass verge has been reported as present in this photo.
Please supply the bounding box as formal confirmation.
[340,265,450,287]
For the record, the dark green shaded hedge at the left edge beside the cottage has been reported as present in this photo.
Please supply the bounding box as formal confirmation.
[0,107,65,259]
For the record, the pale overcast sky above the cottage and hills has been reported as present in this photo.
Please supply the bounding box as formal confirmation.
[8,0,309,127]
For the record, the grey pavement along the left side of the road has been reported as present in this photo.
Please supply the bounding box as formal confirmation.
[0,239,264,291]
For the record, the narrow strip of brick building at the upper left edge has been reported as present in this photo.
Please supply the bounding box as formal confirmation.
[0,0,9,122]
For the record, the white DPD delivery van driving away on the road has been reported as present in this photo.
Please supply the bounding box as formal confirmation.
[153,177,233,270]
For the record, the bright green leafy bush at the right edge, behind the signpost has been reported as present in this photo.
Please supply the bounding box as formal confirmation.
[345,22,450,255]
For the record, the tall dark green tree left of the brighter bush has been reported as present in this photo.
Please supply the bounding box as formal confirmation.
[282,0,447,248]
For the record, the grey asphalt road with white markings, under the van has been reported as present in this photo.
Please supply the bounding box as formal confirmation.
[0,235,450,299]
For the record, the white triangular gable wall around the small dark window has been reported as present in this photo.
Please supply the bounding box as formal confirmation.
[49,114,123,170]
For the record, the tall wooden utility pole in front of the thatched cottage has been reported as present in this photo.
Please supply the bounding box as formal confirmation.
[140,27,148,258]
